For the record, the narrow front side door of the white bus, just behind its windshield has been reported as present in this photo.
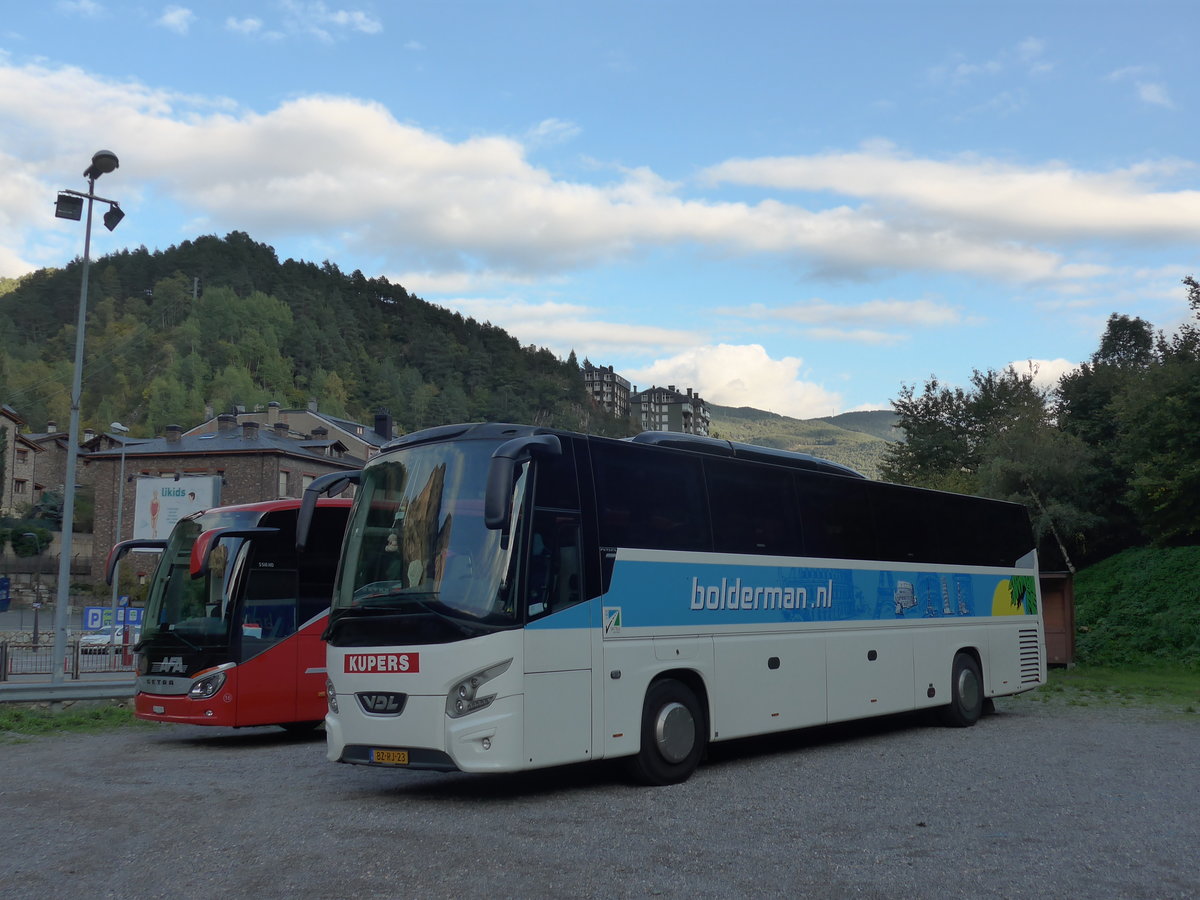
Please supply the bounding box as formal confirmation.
[521,509,595,766]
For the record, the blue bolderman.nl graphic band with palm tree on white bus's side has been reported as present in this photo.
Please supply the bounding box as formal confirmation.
[606,560,1037,628]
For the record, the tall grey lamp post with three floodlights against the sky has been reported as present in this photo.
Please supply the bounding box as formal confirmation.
[50,150,124,684]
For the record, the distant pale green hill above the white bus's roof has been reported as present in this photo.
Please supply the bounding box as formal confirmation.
[709,406,902,478]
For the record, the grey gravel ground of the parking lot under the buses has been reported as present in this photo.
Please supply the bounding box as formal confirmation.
[0,698,1200,900]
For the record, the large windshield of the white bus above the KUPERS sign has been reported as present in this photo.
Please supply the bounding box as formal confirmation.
[330,442,524,642]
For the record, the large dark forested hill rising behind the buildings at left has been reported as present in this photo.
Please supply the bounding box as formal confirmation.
[0,232,626,436]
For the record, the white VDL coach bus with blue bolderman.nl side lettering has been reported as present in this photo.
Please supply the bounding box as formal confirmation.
[307,424,1045,784]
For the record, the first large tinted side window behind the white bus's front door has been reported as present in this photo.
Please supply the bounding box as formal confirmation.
[592,442,712,550]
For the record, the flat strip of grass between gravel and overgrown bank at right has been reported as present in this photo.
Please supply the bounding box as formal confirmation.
[1024,666,1200,713]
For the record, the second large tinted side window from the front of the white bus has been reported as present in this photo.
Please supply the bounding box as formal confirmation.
[704,460,800,556]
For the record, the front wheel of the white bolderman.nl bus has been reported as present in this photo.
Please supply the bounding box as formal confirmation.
[630,678,708,785]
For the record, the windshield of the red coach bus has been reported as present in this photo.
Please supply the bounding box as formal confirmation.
[142,510,262,650]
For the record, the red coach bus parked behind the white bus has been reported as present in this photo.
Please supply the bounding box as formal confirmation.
[107,499,350,731]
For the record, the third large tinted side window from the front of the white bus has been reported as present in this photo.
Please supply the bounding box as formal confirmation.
[794,472,875,559]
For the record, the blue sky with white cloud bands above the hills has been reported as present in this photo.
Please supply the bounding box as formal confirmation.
[0,0,1200,419]
